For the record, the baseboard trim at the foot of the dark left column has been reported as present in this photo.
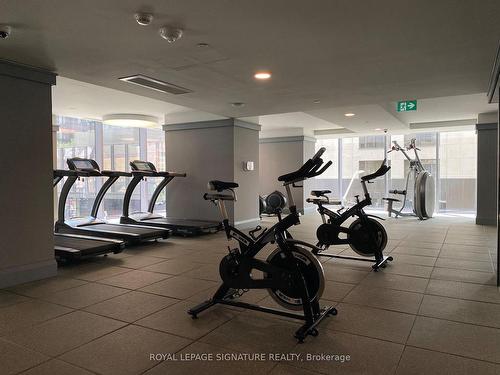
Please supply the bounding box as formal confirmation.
[0,259,57,288]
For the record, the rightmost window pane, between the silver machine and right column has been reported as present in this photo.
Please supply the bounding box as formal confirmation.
[438,131,477,212]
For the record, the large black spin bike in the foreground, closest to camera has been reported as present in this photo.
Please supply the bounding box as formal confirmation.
[188,148,337,342]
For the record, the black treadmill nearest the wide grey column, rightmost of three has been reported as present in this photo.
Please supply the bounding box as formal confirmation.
[120,160,222,237]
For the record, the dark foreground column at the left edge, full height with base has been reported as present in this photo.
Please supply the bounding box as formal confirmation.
[0,61,57,288]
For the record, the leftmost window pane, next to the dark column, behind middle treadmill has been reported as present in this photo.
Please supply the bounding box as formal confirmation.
[56,116,98,218]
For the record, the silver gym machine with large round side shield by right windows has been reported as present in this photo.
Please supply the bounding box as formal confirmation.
[382,138,436,220]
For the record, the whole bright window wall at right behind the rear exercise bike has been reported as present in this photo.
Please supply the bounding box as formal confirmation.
[313,130,477,213]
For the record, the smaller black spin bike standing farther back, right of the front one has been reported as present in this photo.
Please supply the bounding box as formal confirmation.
[306,159,393,271]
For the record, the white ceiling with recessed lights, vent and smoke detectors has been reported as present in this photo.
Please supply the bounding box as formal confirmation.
[0,0,500,132]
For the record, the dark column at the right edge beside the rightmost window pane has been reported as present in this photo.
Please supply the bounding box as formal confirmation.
[476,113,498,225]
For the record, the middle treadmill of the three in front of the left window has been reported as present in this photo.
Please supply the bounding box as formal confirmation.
[55,158,171,244]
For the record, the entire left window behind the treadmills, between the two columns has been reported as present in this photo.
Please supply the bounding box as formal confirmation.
[56,117,165,218]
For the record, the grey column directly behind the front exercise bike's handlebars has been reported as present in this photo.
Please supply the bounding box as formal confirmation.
[259,135,316,213]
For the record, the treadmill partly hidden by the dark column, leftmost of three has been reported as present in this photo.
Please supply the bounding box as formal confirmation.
[53,169,125,261]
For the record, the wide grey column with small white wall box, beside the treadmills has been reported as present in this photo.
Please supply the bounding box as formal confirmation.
[163,119,260,228]
